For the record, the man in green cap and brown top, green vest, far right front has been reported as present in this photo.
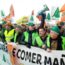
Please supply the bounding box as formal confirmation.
[46,26,65,51]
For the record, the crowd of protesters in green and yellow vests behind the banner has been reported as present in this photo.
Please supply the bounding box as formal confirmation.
[0,22,65,51]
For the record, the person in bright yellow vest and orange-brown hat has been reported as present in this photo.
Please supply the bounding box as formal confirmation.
[4,23,14,43]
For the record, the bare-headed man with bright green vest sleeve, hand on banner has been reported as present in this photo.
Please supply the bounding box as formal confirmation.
[35,27,47,49]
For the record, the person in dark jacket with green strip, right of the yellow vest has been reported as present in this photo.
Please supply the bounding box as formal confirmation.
[14,25,22,44]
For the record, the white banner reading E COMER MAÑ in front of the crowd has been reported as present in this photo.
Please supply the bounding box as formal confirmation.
[10,45,65,65]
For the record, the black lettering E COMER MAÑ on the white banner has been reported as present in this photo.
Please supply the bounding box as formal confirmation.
[13,48,65,65]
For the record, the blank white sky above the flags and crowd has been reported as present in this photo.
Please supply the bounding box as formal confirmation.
[0,0,65,20]
